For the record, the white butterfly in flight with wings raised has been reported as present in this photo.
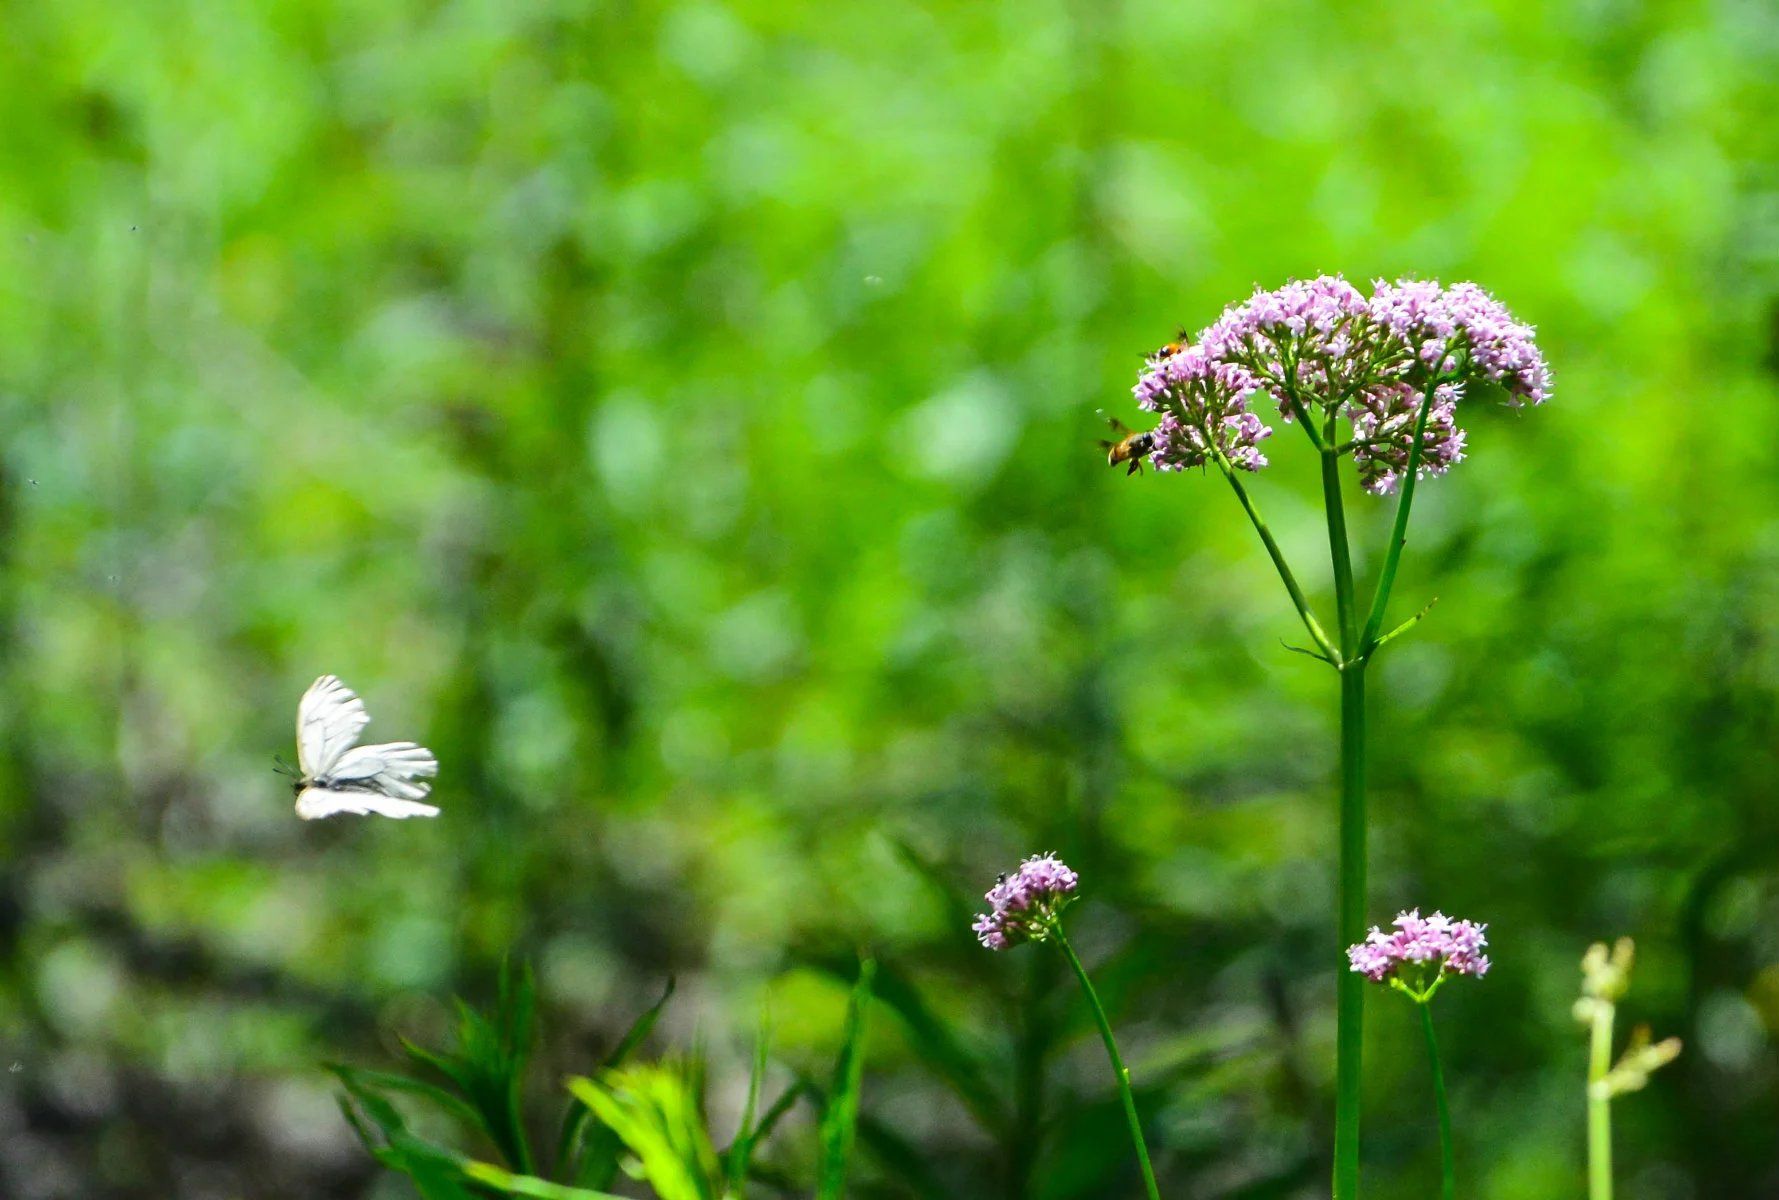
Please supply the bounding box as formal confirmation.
[295,676,439,821]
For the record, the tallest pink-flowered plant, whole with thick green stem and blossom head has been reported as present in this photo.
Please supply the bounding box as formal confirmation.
[1112,276,1551,1200]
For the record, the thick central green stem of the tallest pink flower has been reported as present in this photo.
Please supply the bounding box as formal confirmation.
[1322,433,1366,1200]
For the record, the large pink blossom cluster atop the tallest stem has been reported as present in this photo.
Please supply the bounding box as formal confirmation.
[1135,276,1551,492]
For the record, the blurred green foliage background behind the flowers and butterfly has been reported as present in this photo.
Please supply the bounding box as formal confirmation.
[0,0,1779,1200]
